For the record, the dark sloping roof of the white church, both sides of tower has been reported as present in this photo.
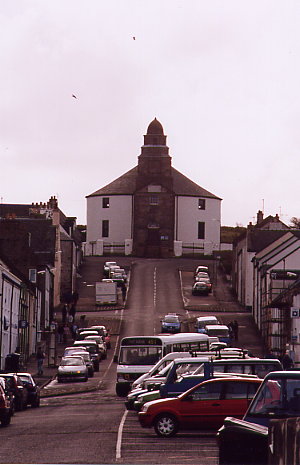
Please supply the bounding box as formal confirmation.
[86,166,221,200]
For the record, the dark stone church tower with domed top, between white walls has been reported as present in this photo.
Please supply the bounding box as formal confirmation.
[133,118,175,257]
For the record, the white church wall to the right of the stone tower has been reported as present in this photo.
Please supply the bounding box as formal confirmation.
[175,196,221,254]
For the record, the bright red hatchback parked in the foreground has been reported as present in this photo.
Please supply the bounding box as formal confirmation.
[138,376,262,437]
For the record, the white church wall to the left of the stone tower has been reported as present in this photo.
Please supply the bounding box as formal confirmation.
[87,195,132,243]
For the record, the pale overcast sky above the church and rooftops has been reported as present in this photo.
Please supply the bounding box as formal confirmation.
[0,0,300,226]
